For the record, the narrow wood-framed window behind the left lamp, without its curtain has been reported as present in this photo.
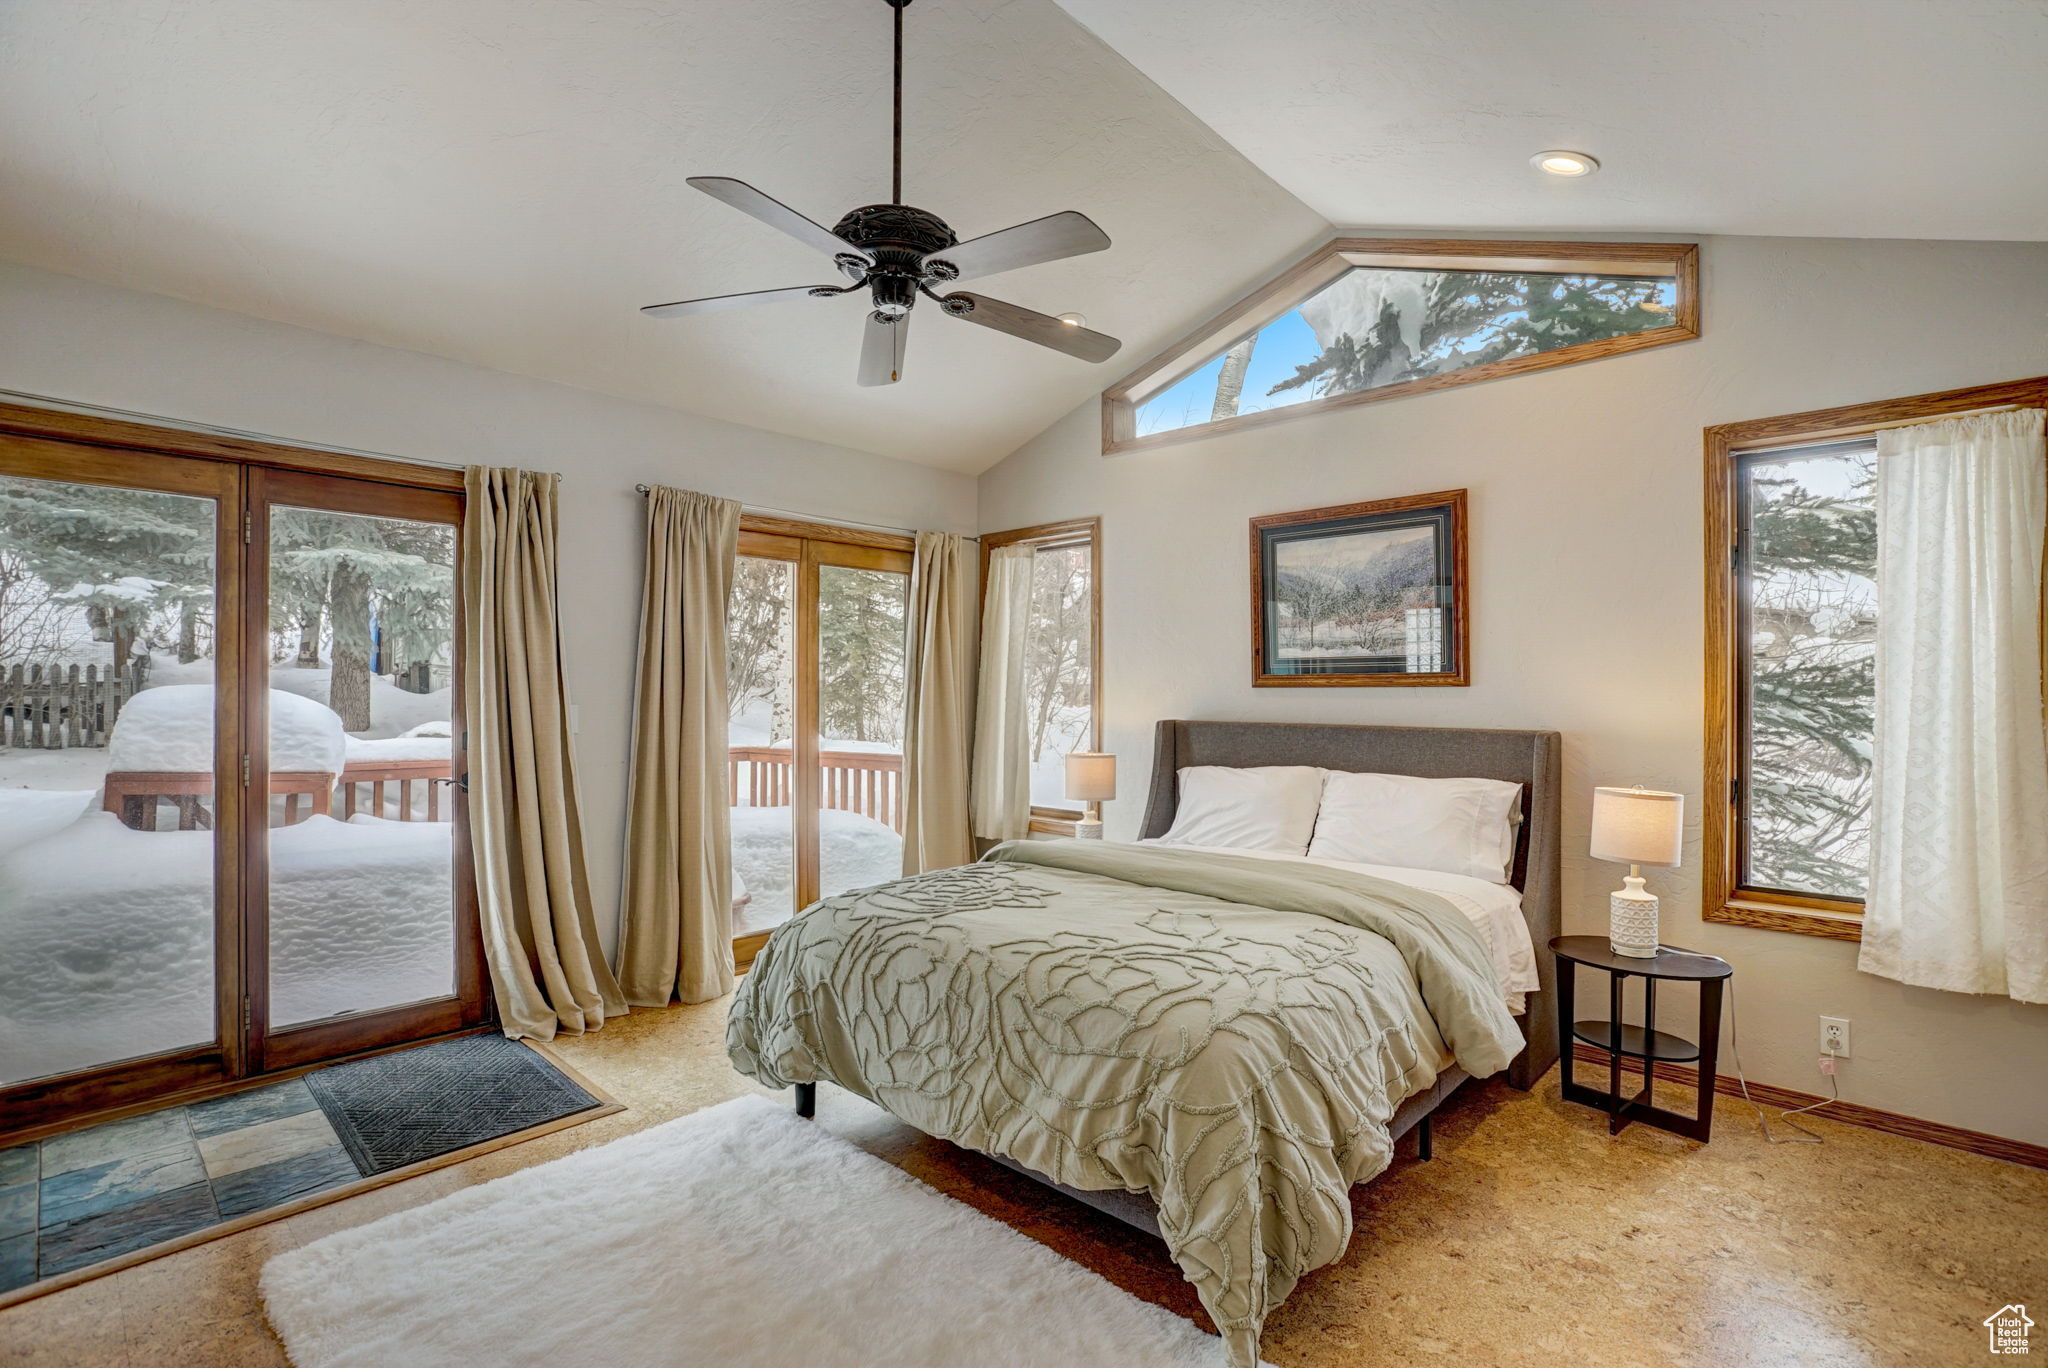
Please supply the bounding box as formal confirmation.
[981,518,1102,833]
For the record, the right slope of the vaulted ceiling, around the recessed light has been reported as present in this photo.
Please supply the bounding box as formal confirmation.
[1059,0,2048,242]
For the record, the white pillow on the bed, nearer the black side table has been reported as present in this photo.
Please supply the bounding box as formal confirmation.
[1309,770,1522,883]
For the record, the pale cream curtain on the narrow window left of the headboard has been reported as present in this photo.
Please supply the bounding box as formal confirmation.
[973,543,1036,842]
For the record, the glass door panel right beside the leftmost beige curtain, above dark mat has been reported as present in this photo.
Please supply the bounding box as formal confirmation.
[244,469,483,1069]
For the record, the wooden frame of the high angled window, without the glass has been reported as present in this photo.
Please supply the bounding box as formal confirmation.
[1102,238,1700,457]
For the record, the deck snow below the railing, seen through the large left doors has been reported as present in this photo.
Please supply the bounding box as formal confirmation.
[0,806,455,1085]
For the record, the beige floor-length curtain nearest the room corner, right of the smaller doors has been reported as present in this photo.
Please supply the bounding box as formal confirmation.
[903,532,975,874]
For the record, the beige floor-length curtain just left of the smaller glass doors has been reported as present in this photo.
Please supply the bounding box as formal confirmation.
[618,485,739,1008]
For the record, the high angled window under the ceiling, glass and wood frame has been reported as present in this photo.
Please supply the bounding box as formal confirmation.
[1102,238,1700,453]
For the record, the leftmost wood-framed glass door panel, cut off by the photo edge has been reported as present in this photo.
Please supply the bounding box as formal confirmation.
[0,440,242,1130]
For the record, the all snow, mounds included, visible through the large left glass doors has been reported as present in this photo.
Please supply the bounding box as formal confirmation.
[0,663,455,1085]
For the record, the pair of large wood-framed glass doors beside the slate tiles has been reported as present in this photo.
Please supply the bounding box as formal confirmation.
[0,434,487,1135]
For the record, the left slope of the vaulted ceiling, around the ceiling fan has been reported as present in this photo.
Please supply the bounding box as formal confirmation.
[0,0,1323,471]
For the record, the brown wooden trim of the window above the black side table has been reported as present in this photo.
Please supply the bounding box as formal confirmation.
[1700,375,2048,940]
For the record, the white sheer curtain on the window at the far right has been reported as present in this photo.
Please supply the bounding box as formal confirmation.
[1858,410,2048,1001]
